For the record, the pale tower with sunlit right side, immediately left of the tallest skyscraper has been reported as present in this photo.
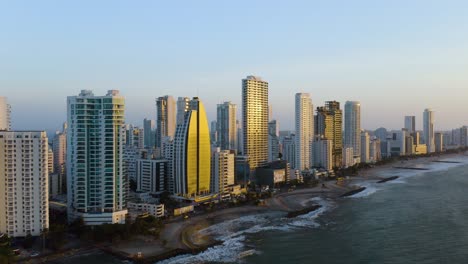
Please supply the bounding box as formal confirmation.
[217,102,237,151]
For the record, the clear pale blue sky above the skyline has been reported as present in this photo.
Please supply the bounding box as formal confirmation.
[0,0,468,130]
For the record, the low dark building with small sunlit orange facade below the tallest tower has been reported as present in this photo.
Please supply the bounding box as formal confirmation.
[255,160,291,187]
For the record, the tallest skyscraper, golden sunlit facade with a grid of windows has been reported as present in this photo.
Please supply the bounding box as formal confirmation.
[242,76,268,171]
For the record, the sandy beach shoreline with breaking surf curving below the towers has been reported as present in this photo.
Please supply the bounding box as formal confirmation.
[46,153,468,263]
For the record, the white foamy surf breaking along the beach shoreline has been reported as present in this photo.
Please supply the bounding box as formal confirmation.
[159,157,468,264]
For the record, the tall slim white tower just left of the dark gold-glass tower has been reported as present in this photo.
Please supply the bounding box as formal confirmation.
[291,93,314,171]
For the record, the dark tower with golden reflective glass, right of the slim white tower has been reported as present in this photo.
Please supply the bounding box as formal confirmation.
[314,101,343,168]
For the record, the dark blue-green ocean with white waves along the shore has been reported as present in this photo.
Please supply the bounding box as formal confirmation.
[161,156,468,264]
